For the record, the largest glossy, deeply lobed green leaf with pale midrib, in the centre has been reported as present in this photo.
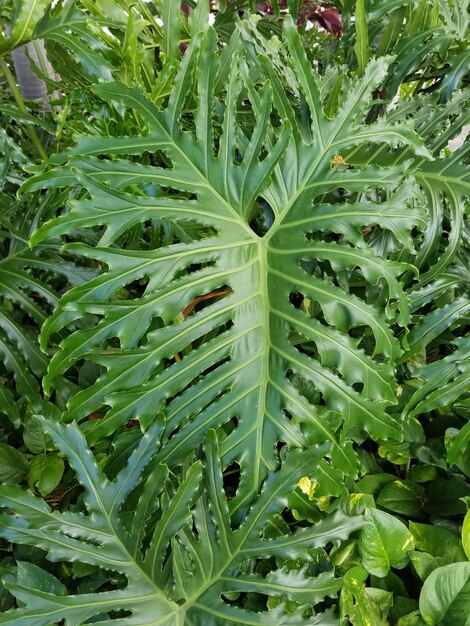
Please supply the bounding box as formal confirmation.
[28,20,434,512]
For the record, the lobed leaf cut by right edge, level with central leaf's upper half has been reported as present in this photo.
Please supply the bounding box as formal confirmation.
[348,89,470,286]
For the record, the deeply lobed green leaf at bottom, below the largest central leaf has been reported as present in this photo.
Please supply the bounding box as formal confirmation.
[0,419,362,626]
